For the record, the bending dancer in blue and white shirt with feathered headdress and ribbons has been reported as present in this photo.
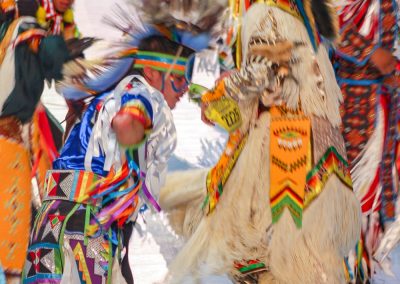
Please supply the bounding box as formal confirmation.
[24,1,228,283]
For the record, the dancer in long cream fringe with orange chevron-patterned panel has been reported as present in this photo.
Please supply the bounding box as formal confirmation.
[160,0,361,283]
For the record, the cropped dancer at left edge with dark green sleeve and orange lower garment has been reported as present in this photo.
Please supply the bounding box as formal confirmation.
[0,0,86,282]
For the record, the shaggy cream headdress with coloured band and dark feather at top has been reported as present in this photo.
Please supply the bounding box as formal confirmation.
[234,0,342,126]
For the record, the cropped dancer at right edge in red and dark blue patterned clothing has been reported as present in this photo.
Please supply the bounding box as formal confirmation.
[335,0,400,280]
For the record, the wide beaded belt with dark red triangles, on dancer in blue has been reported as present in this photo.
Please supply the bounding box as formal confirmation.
[43,170,102,204]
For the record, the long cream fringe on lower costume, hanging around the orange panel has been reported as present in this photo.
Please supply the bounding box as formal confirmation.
[161,113,361,283]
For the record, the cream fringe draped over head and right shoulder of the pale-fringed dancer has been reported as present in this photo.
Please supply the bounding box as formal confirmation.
[242,3,342,126]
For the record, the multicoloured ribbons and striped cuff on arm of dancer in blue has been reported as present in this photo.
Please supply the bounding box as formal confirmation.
[79,83,158,235]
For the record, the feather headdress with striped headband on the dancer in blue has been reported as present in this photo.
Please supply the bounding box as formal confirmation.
[64,0,227,100]
